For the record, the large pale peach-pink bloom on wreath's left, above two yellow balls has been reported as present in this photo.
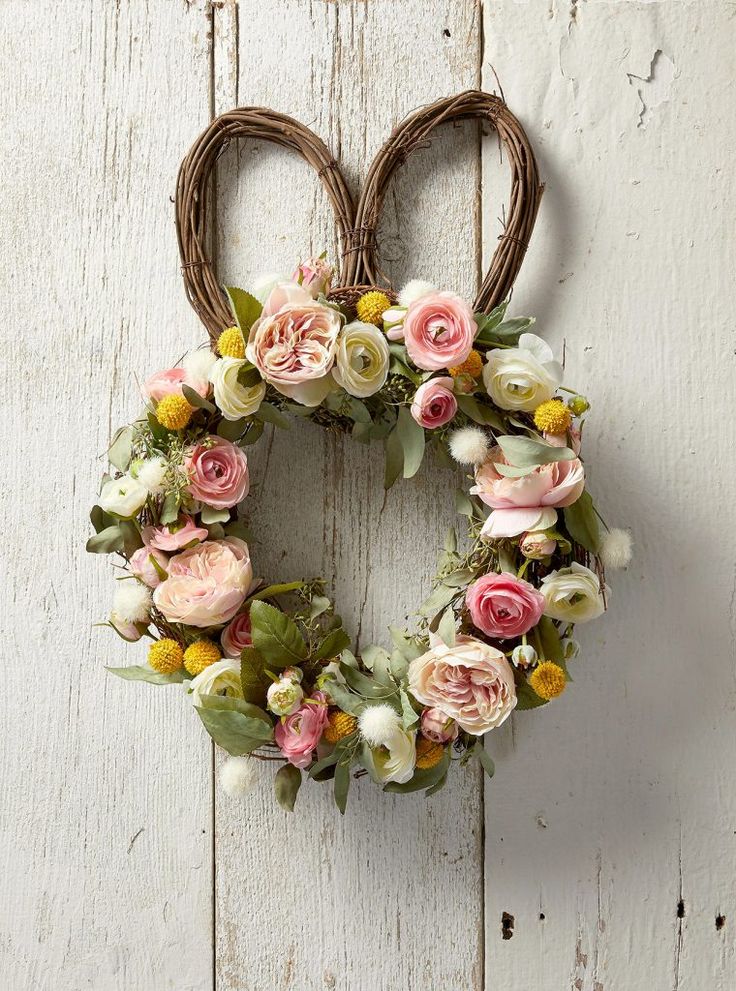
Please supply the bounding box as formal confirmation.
[153,537,253,627]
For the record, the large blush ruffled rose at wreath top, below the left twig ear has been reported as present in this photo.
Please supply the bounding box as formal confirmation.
[246,283,341,406]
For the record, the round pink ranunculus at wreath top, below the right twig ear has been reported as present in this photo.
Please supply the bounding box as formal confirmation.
[404,292,478,371]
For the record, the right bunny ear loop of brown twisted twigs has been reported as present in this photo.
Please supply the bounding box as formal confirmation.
[343,90,544,312]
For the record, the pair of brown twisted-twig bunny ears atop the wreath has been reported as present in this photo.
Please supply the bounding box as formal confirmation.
[176,90,544,340]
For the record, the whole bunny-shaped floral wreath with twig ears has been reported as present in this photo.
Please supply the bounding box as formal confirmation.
[87,92,630,812]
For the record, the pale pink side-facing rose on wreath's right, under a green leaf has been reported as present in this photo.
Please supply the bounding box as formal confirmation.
[470,447,585,539]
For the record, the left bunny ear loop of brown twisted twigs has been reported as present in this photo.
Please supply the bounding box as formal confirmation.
[176,107,355,341]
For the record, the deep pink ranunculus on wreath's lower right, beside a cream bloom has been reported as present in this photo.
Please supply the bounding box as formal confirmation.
[465,572,544,640]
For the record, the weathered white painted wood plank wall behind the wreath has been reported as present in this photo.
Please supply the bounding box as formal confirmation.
[0,0,736,991]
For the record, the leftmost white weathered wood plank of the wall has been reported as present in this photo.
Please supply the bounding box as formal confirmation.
[0,0,213,991]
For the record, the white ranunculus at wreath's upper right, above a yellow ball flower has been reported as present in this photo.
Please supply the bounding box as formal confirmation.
[483,334,562,413]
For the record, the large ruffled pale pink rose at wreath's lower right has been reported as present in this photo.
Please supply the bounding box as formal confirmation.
[409,636,516,736]
